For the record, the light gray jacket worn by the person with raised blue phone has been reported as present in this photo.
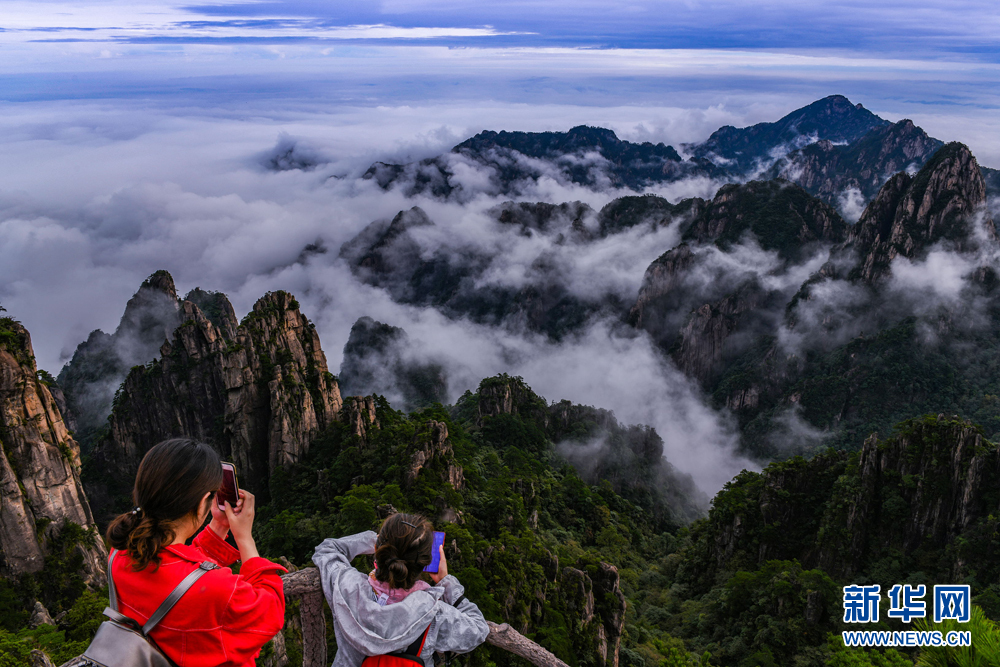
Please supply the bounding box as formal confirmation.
[313,531,490,667]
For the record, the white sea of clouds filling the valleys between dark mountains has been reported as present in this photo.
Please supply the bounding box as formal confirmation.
[0,85,1000,493]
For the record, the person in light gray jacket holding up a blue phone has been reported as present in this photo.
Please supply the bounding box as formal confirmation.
[313,514,490,667]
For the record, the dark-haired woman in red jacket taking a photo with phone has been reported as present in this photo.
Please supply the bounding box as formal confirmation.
[107,439,285,667]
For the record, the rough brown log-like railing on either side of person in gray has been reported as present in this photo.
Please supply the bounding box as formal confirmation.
[281,567,568,667]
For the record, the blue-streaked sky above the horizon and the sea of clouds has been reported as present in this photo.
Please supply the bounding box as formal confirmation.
[0,0,1000,120]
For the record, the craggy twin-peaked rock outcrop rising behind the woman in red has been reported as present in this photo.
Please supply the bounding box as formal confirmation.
[88,292,341,516]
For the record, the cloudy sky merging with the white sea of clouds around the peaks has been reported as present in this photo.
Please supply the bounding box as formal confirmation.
[0,0,1000,489]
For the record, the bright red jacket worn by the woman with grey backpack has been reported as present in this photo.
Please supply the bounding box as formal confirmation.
[114,528,286,667]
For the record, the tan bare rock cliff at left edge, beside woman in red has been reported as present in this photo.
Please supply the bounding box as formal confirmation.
[0,318,107,586]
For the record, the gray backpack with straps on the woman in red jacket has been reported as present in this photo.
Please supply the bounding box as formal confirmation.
[81,550,219,667]
